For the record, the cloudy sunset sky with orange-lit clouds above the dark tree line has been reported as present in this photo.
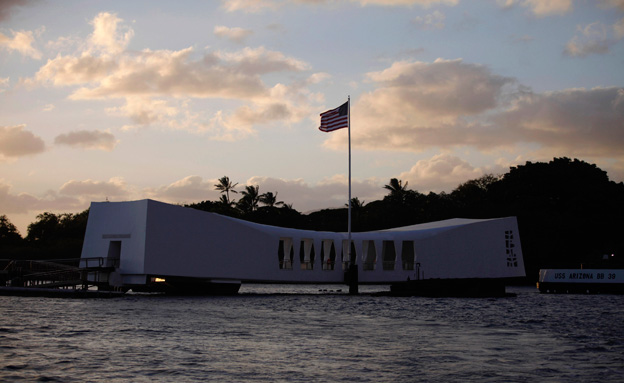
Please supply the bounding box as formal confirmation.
[0,0,624,235]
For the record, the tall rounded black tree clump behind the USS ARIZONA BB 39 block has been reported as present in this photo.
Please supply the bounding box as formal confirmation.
[489,158,624,275]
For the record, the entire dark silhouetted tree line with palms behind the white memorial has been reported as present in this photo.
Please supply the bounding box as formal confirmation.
[0,157,624,280]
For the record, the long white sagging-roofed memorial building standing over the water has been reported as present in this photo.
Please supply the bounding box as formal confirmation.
[82,200,524,283]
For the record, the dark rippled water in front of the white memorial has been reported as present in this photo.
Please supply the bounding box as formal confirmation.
[0,285,624,382]
